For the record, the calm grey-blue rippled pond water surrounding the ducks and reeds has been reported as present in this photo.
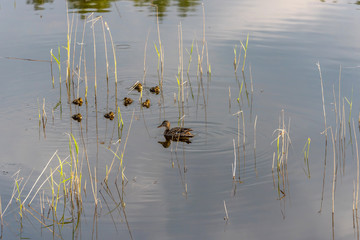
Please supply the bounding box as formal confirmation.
[0,0,360,239]
